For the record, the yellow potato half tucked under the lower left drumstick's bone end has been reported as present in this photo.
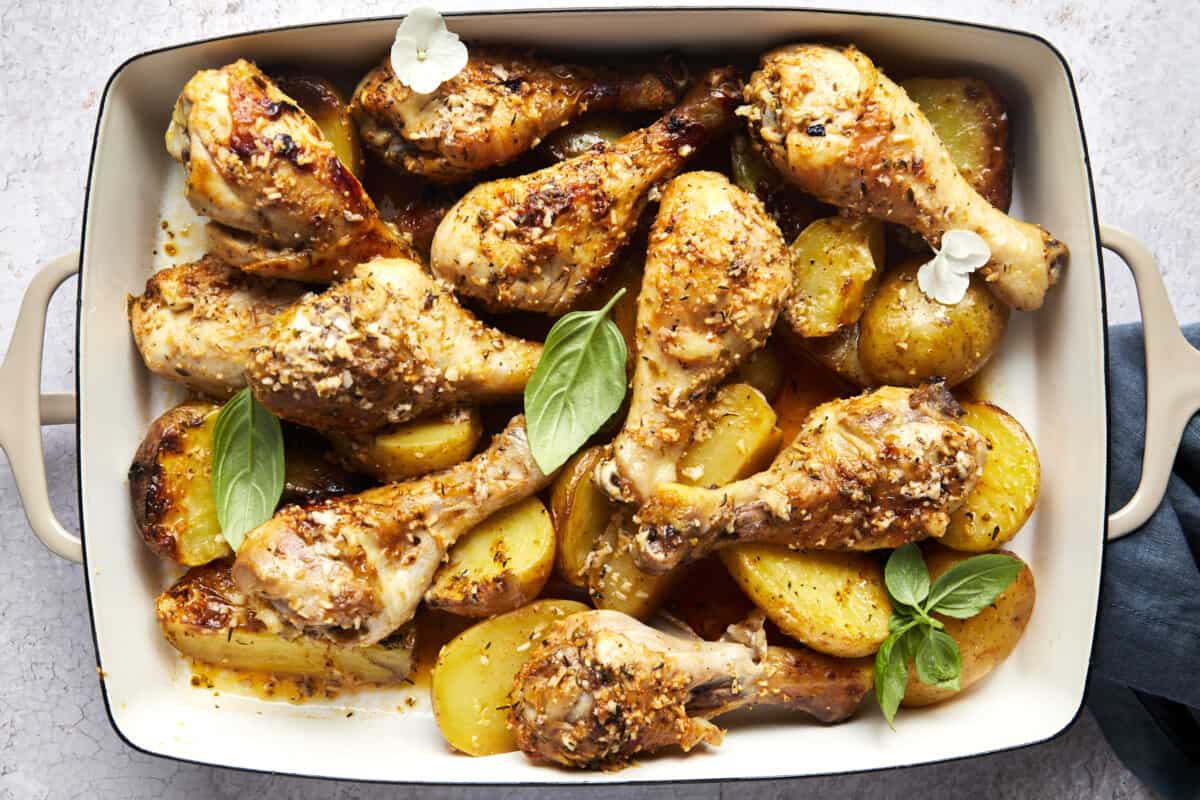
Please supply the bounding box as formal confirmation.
[425,498,554,616]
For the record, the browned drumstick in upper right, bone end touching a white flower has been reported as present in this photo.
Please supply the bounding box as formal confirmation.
[738,44,1067,311]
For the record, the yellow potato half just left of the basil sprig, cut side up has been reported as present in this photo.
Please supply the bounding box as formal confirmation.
[720,545,892,658]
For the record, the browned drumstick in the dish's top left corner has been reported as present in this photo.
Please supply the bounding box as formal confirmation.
[167,60,409,282]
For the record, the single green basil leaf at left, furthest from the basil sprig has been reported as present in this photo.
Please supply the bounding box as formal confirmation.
[212,387,283,552]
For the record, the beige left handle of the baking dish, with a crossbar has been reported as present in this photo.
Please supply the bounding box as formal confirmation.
[0,252,83,561]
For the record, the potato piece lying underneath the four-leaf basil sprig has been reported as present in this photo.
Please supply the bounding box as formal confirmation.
[901,541,1037,708]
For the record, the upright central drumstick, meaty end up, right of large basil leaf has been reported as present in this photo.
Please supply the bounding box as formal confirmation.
[600,172,792,501]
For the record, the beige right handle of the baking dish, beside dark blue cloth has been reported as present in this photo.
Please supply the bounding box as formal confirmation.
[1100,225,1200,541]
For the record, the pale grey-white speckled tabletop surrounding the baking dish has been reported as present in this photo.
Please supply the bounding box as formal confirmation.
[0,0,1200,800]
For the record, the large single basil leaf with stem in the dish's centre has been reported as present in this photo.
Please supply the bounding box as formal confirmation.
[524,289,626,475]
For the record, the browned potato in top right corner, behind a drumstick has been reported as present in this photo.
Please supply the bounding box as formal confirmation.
[900,78,1013,211]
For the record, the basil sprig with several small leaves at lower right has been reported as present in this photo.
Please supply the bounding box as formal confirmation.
[875,545,1025,724]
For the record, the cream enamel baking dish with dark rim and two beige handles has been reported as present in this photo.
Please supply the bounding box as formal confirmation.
[0,7,1200,783]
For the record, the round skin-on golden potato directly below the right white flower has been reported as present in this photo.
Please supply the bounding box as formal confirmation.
[858,261,1009,386]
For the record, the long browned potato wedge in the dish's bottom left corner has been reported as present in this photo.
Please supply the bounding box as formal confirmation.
[156,560,415,690]
